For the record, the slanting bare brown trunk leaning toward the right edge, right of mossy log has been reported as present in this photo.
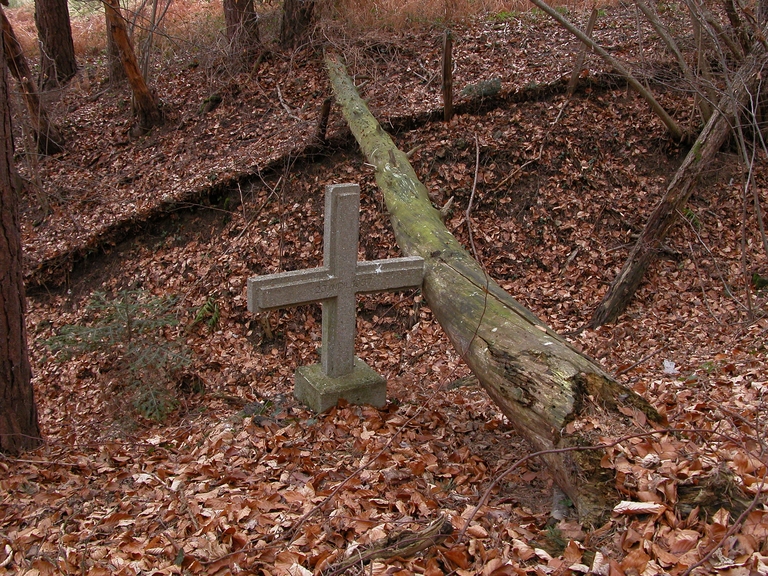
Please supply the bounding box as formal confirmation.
[591,44,768,327]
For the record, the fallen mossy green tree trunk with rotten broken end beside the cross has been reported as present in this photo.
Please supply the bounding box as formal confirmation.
[326,56,660,524]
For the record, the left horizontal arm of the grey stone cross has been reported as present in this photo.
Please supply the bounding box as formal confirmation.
[248,268,339,312]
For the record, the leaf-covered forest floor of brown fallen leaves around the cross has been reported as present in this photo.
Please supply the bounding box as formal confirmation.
[0,6,768,576]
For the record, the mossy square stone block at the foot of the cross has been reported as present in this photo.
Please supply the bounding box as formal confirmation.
[293,357,387,413]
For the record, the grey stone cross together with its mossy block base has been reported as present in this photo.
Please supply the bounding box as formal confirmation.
[248,184,424,412]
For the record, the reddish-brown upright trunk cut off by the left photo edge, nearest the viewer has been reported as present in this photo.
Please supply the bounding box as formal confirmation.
[0,24,41,454]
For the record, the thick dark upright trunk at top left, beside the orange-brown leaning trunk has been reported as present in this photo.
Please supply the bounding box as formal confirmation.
[35,0,77,89]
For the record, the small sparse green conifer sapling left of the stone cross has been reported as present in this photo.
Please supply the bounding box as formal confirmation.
[46,290,191,421]
